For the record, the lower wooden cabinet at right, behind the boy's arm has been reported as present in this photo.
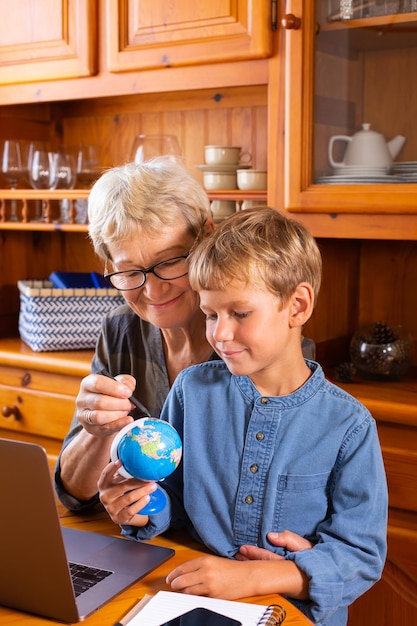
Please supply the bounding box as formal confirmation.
[330,370,417,626]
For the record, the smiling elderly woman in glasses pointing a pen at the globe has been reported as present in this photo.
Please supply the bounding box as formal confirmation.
[55,157,314,511]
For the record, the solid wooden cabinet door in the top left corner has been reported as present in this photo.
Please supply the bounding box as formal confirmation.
[0,0,97,84]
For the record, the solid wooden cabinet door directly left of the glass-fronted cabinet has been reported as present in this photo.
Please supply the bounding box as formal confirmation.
[106,0,272,72]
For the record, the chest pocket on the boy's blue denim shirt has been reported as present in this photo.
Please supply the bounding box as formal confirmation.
[274,472,331,536]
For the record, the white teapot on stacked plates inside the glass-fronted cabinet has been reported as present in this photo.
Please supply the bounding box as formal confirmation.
[329,124,405,170]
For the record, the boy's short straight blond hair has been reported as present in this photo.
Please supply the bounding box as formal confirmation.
[189,207,322,306]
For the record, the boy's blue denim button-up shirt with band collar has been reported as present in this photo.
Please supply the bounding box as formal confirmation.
[122,361,387,626]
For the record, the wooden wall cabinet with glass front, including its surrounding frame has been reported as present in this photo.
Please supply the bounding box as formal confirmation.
[269,0,417,223]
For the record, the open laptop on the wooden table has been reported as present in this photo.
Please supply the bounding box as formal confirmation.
[0,439,174,623]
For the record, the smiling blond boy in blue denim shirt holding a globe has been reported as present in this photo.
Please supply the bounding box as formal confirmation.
[99,208,387,626]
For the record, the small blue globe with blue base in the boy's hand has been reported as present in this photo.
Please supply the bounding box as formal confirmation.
[110,417,182,515]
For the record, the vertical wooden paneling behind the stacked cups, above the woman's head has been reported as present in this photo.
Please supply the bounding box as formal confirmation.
[57,86,267,176]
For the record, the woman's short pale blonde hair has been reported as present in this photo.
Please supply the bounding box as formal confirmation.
[88,157,211,260]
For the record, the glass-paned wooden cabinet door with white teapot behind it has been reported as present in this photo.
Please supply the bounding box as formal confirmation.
[282,0,417,216]
